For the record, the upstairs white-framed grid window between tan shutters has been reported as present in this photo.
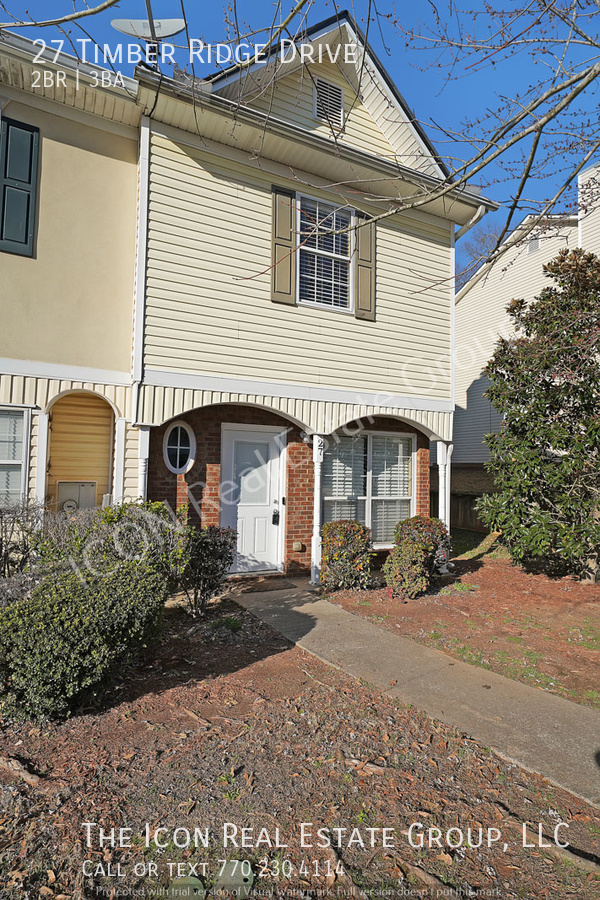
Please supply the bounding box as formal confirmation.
[298,197,353,311]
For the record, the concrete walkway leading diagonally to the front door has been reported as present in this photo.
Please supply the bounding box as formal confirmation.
[235,587,600,804]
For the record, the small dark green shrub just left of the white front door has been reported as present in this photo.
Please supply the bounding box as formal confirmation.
[179,525,237,616]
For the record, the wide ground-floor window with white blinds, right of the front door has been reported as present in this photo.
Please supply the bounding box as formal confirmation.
[323,434,413,544]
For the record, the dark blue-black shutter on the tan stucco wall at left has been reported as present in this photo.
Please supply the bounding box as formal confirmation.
[0,116,40,256]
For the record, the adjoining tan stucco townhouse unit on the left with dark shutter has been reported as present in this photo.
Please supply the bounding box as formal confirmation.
[0,35,140,509]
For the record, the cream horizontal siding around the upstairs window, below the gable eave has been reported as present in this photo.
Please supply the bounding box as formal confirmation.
[144,135,450,399]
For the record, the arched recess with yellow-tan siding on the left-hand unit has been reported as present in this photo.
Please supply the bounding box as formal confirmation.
[46,391,115,510]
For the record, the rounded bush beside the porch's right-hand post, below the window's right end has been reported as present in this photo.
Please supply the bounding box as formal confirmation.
[383,516,451,599]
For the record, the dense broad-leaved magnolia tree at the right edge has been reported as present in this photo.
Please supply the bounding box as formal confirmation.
[479,250,600,578]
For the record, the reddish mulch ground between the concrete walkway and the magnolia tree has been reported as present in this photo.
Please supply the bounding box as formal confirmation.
[327,558,600,709]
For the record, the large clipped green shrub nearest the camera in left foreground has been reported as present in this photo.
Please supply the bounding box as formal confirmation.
[0,562,167,718]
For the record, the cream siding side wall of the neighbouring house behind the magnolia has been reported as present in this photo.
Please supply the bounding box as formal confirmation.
[452,227,577,463]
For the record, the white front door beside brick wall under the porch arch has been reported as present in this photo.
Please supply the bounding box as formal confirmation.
[221,425,285,573]
